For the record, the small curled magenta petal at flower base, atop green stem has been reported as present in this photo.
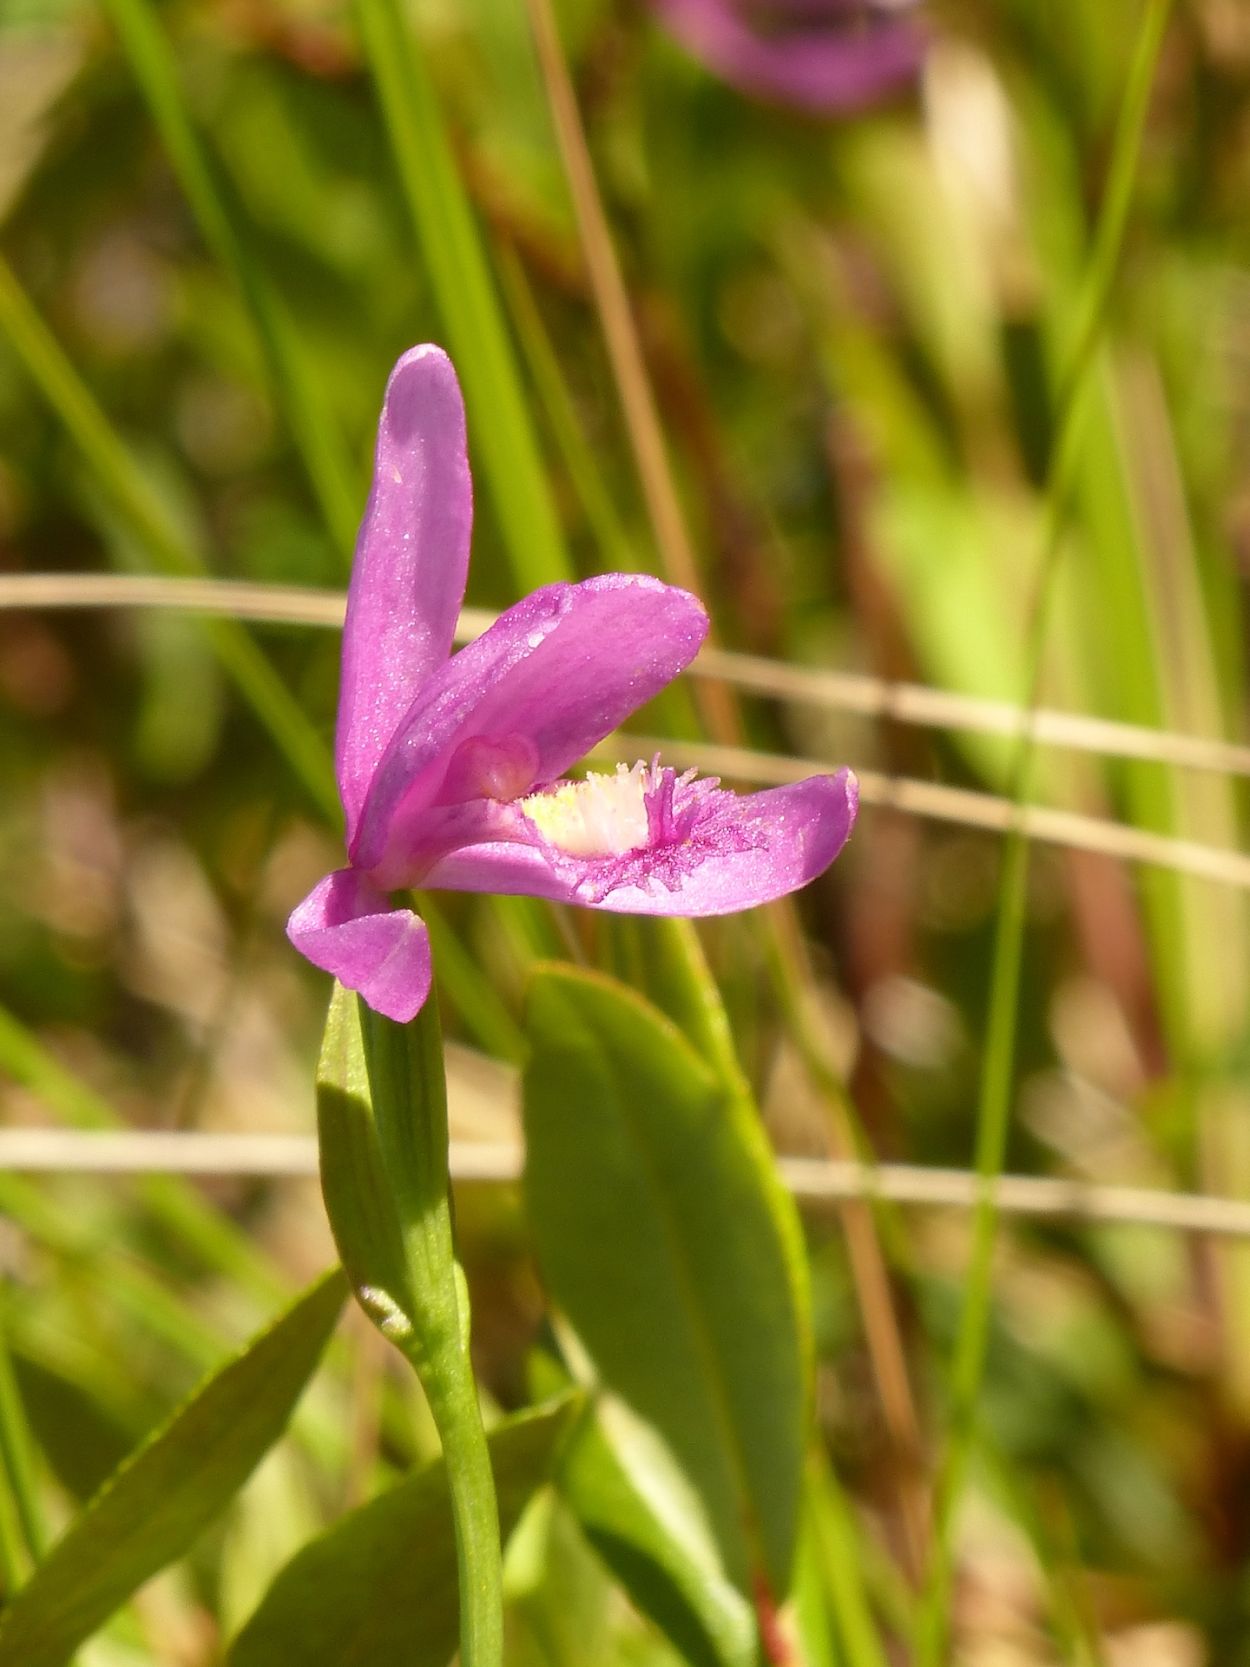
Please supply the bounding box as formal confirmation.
[287,869,432,1025]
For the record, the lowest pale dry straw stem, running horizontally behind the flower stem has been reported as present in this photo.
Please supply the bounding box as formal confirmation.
[0,1129,1250,1239]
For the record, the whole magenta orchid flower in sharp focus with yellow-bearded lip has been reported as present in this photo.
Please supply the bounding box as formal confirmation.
[287,347,857,1024]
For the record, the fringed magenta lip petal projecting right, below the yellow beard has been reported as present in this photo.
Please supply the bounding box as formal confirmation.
[427,770,858,915]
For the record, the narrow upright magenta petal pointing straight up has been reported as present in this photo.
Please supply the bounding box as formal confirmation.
[335,347,473,840]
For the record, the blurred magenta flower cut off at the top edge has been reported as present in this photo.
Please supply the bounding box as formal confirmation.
[653,0,927,115]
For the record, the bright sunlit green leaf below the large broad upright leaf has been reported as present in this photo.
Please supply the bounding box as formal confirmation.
[557,1397,758,1667]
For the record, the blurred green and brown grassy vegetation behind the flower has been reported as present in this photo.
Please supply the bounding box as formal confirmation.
[0,0,1250,1667]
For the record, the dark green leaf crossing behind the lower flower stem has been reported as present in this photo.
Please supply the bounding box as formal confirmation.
[227,1395,580,1667]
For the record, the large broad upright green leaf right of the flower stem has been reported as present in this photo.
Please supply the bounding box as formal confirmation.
[525,969,808,1594]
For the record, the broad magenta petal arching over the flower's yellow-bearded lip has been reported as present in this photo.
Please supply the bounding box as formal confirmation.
[348,573,707,885]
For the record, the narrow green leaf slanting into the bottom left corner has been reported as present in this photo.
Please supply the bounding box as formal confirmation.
[0,1270,345,1667]
